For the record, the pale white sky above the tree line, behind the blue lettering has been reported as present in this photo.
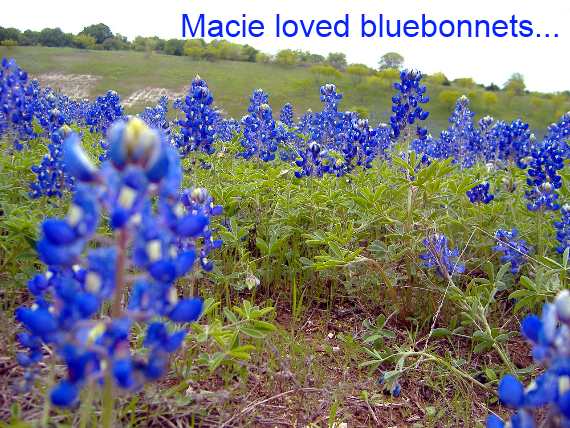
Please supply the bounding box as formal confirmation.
[0,0,570,92]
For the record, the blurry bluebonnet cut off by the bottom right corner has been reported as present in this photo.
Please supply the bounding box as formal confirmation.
[487,290,570,428]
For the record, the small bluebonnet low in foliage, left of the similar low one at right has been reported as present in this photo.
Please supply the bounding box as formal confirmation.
[420,233,465,279]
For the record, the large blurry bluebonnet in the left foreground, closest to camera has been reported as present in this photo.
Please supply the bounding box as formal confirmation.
[16,119,221,406]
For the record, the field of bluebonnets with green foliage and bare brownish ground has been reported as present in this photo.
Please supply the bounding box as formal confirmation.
[0,55,570,427]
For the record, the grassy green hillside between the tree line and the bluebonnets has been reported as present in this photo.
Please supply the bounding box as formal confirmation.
[0,47,570,134]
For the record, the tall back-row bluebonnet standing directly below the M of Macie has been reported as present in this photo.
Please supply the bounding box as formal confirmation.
[175,76,219,156]
